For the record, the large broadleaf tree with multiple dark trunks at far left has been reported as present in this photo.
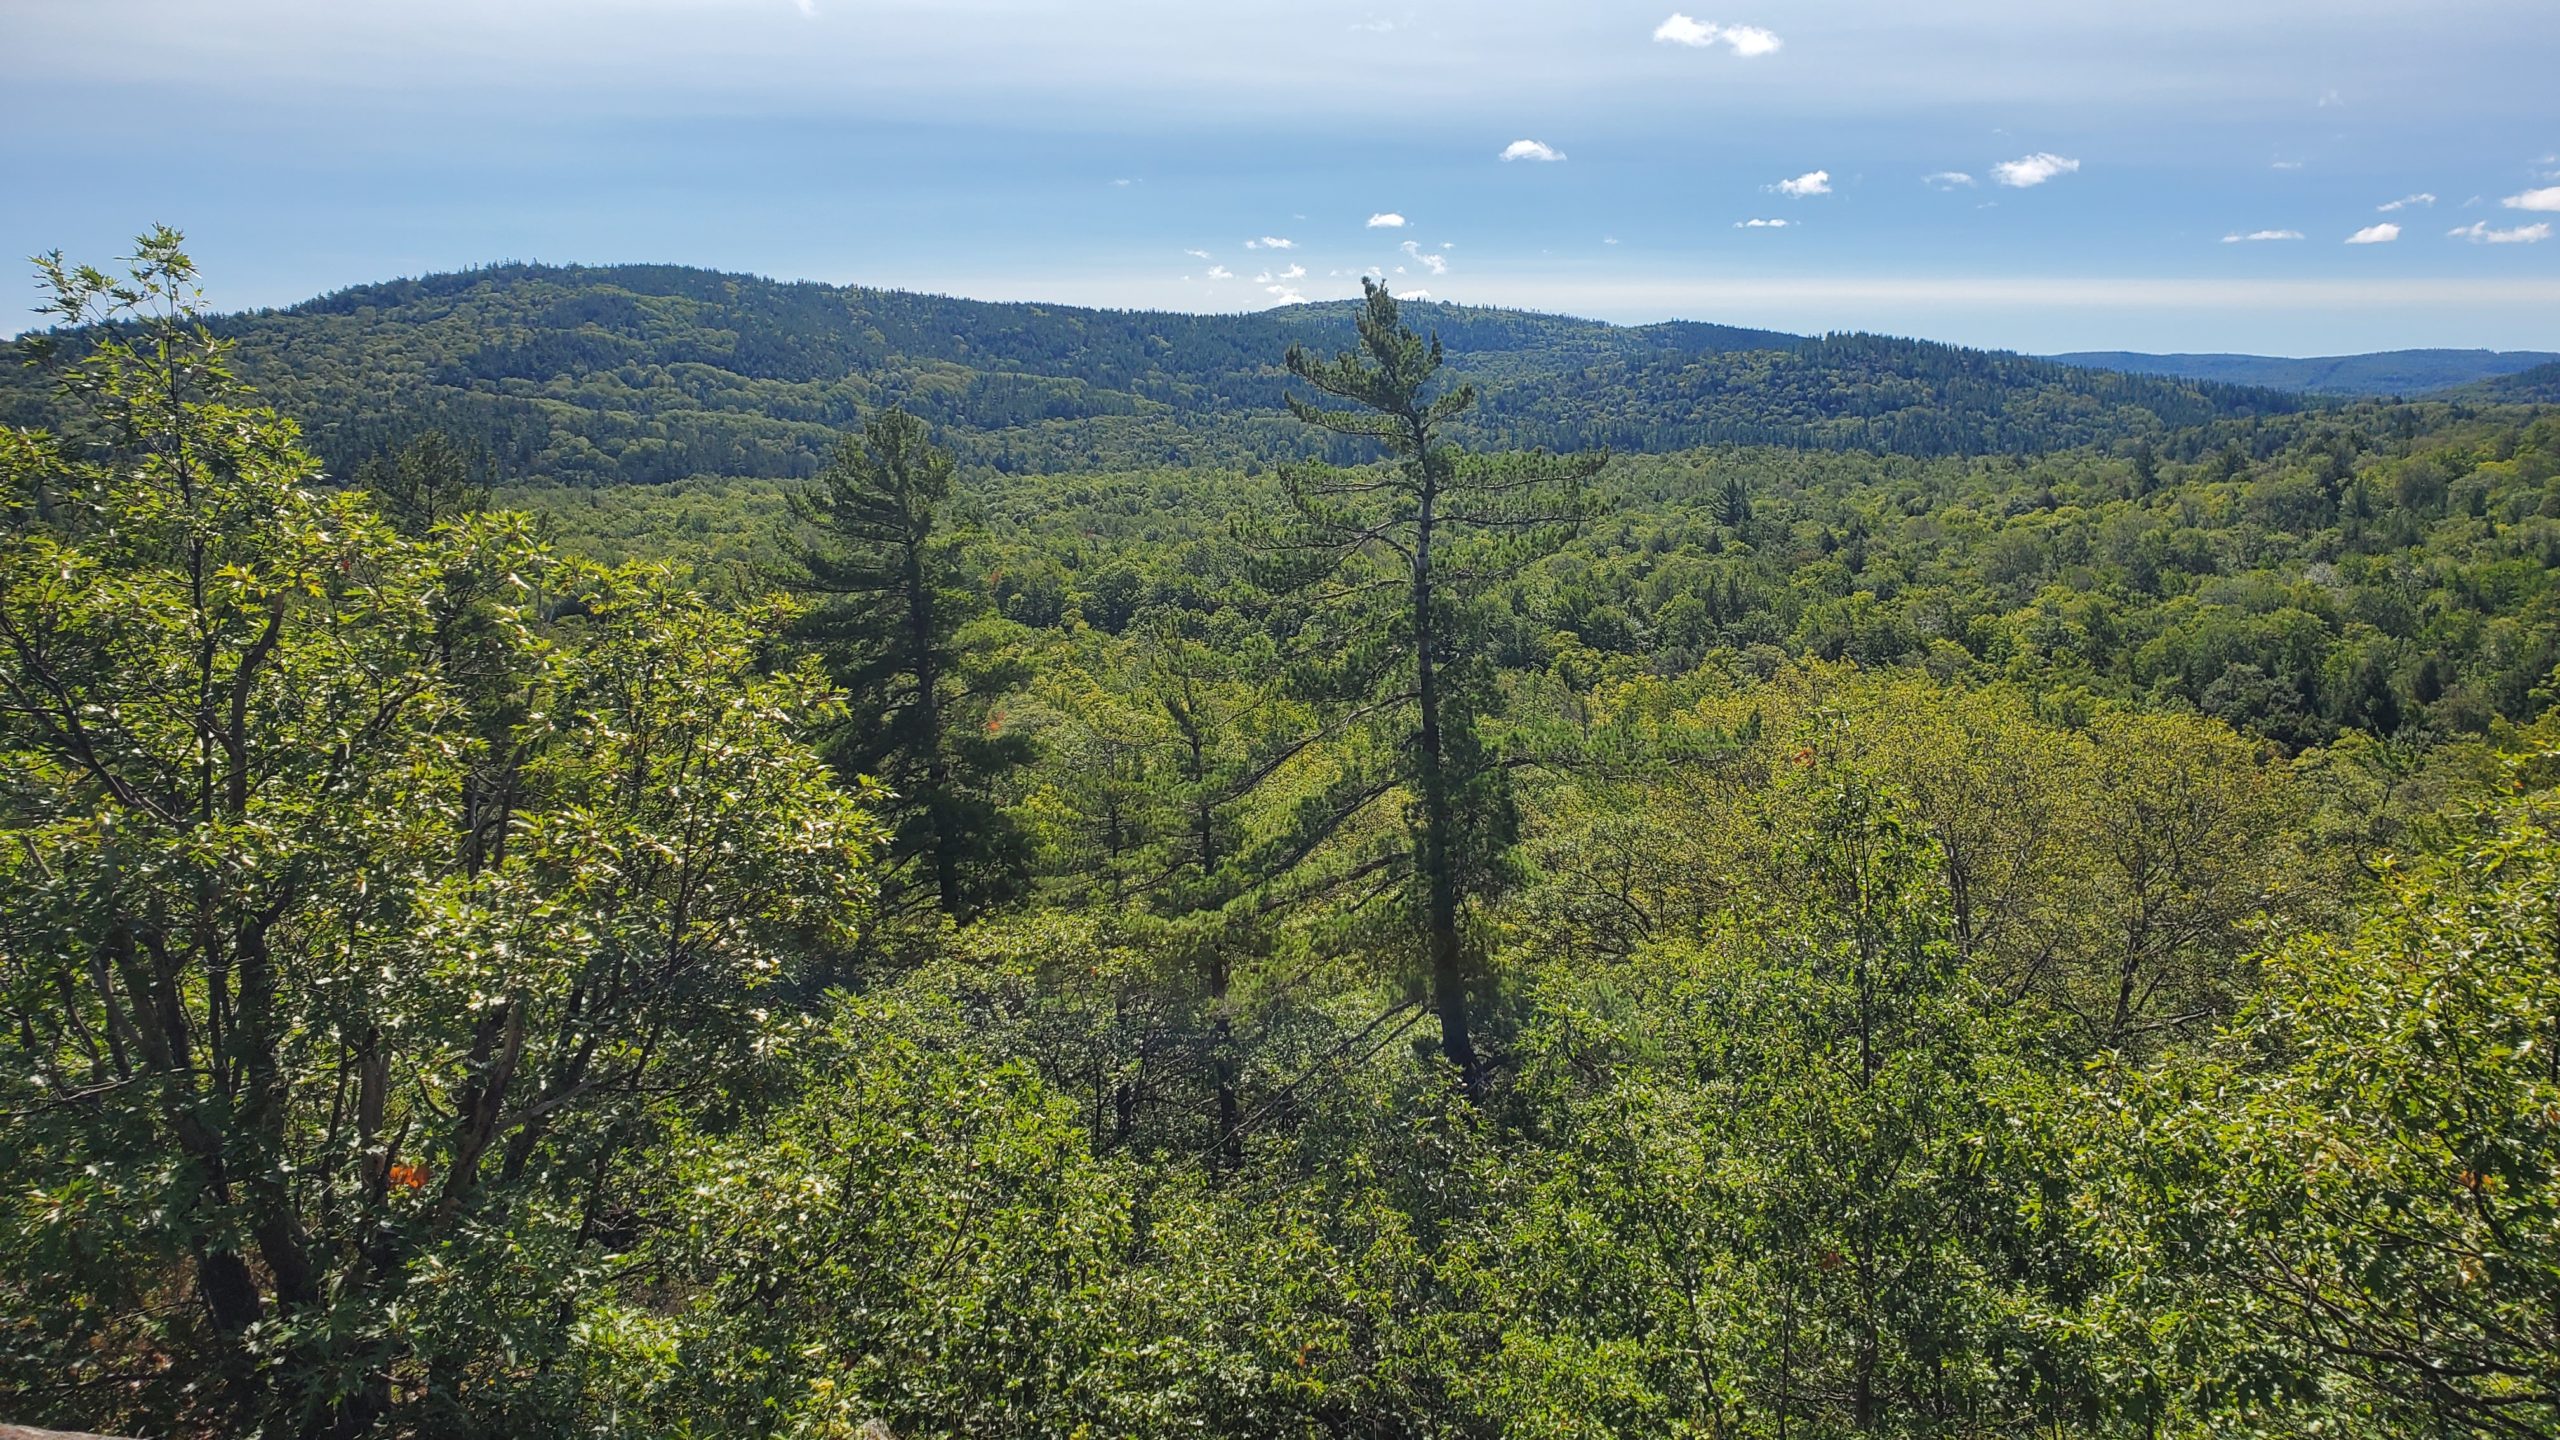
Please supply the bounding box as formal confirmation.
[0,231,876,1435]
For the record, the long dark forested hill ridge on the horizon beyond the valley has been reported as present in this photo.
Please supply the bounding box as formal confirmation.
[0,264,2304,484]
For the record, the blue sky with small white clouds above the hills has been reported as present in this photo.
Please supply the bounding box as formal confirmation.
[0,0,2560,354]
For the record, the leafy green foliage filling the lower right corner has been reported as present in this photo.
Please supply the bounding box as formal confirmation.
[2081,792,2560,1435]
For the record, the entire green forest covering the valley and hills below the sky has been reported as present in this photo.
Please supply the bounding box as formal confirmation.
[0,233,2560,1440]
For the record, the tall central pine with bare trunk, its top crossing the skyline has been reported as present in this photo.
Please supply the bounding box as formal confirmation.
[1265,282,1608,1097]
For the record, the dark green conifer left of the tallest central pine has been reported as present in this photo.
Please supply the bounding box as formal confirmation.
[781,405,1032,922]
